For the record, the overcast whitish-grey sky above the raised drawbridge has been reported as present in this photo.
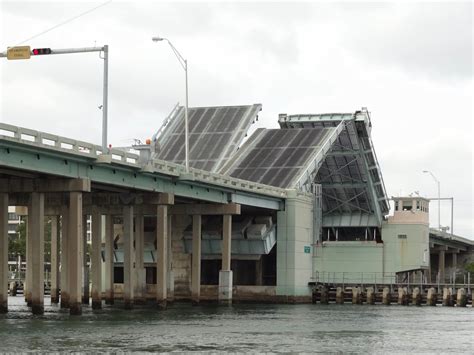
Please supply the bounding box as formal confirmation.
[0,1,474,239]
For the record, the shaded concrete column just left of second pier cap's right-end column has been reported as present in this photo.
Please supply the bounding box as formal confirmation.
[134,212,146,304]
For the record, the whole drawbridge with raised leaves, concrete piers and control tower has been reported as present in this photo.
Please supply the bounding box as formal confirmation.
[0,104,474,314]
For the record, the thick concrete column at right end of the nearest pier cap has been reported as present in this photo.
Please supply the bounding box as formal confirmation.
[68,192,84,315]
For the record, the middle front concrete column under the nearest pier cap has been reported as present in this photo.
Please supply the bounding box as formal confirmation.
[28,192,44,314]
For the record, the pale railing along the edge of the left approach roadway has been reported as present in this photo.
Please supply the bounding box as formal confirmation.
[0,123,296,198]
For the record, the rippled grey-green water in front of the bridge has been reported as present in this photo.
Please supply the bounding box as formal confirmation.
[0,297,474,354]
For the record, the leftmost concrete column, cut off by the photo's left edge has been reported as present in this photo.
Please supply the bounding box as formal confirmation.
[0,193,8,313]
